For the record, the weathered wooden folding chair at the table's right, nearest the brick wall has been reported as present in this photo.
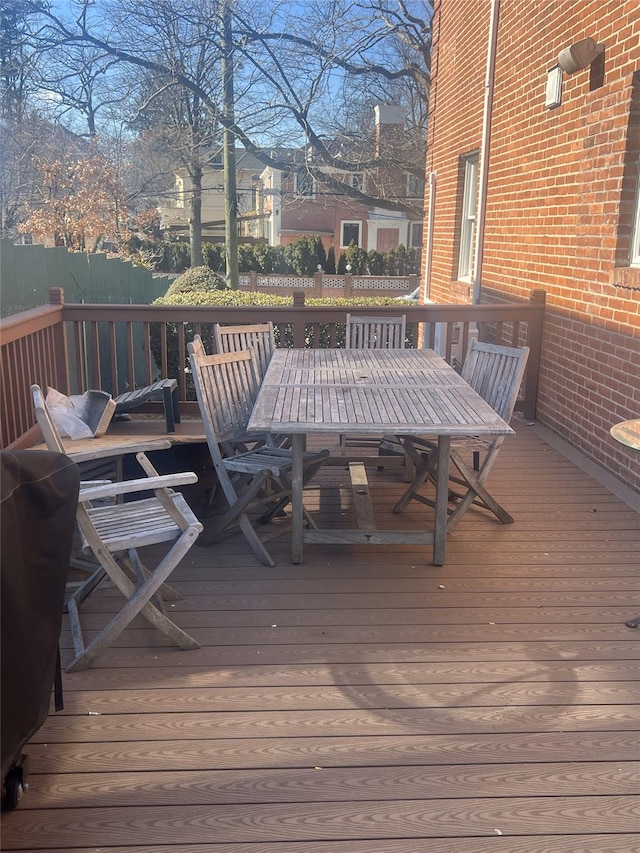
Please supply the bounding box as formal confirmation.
[393,339,529,530]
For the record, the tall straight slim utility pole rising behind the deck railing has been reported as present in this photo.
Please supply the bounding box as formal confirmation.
[222,0,239,290]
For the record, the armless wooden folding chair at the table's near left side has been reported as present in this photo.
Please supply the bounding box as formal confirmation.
[189,335,329,566]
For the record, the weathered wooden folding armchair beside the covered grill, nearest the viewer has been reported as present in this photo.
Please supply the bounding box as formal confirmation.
[31,385,202,672]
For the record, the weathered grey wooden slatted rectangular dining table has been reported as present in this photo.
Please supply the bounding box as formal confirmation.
[248,349,513,565]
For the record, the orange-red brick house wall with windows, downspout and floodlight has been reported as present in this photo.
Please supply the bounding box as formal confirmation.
[424,0,640,489]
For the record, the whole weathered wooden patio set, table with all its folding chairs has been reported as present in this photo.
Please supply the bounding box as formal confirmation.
[32,315,529,671]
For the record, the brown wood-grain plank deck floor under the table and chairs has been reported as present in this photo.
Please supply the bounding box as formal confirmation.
[1,423,640,853]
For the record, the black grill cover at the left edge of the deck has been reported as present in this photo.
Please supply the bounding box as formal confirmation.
[0,450,80,780]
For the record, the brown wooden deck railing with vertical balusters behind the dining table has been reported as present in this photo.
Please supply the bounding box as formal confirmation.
[0,288,545,447]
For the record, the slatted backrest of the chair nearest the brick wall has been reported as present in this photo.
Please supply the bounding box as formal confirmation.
[462,338,529,423]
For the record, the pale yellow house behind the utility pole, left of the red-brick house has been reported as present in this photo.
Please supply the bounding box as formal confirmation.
[158,151,264,242]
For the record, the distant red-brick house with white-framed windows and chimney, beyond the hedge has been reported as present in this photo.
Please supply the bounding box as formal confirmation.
[241,104,424,255]
